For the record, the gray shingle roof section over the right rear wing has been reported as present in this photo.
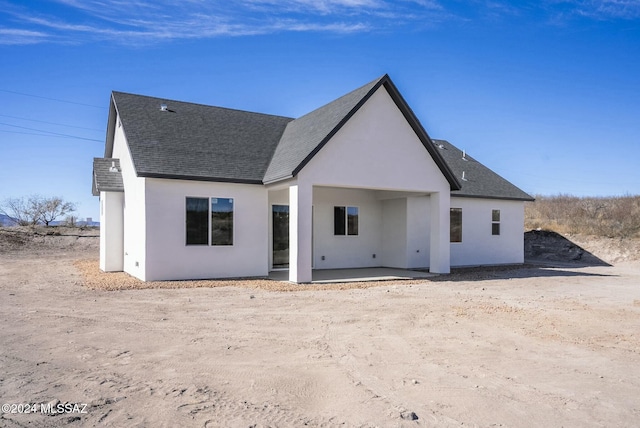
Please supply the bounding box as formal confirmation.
[433,140,533,201]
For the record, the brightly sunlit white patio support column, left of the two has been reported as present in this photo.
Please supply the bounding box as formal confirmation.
[289,184,313,283]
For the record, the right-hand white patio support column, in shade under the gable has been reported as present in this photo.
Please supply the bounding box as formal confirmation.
[429,192,451,273]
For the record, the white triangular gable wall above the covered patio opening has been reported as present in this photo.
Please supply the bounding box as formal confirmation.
[298,87,449,193]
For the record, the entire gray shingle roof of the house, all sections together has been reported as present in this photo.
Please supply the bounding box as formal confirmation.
[94,75,532,200]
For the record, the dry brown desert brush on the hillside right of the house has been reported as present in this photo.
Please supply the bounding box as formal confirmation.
[525,194,640,238]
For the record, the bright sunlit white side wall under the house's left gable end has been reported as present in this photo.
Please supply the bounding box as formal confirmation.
[112,117,147,280]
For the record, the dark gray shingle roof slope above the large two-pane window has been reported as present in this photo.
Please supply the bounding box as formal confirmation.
[113,92,293,184]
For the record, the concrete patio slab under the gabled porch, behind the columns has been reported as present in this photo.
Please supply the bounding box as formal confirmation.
[269,267,438,284]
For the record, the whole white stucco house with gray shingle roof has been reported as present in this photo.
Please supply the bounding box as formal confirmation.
[93,75,532,283]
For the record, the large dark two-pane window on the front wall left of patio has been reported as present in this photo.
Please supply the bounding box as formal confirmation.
[186,198,233,245]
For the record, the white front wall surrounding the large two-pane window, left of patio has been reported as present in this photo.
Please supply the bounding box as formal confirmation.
[140,178,269,281]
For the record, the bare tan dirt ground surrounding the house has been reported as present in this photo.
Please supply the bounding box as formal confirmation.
[0,227,640,428]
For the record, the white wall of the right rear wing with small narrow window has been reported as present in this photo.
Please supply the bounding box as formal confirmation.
[451,197,524,266]
